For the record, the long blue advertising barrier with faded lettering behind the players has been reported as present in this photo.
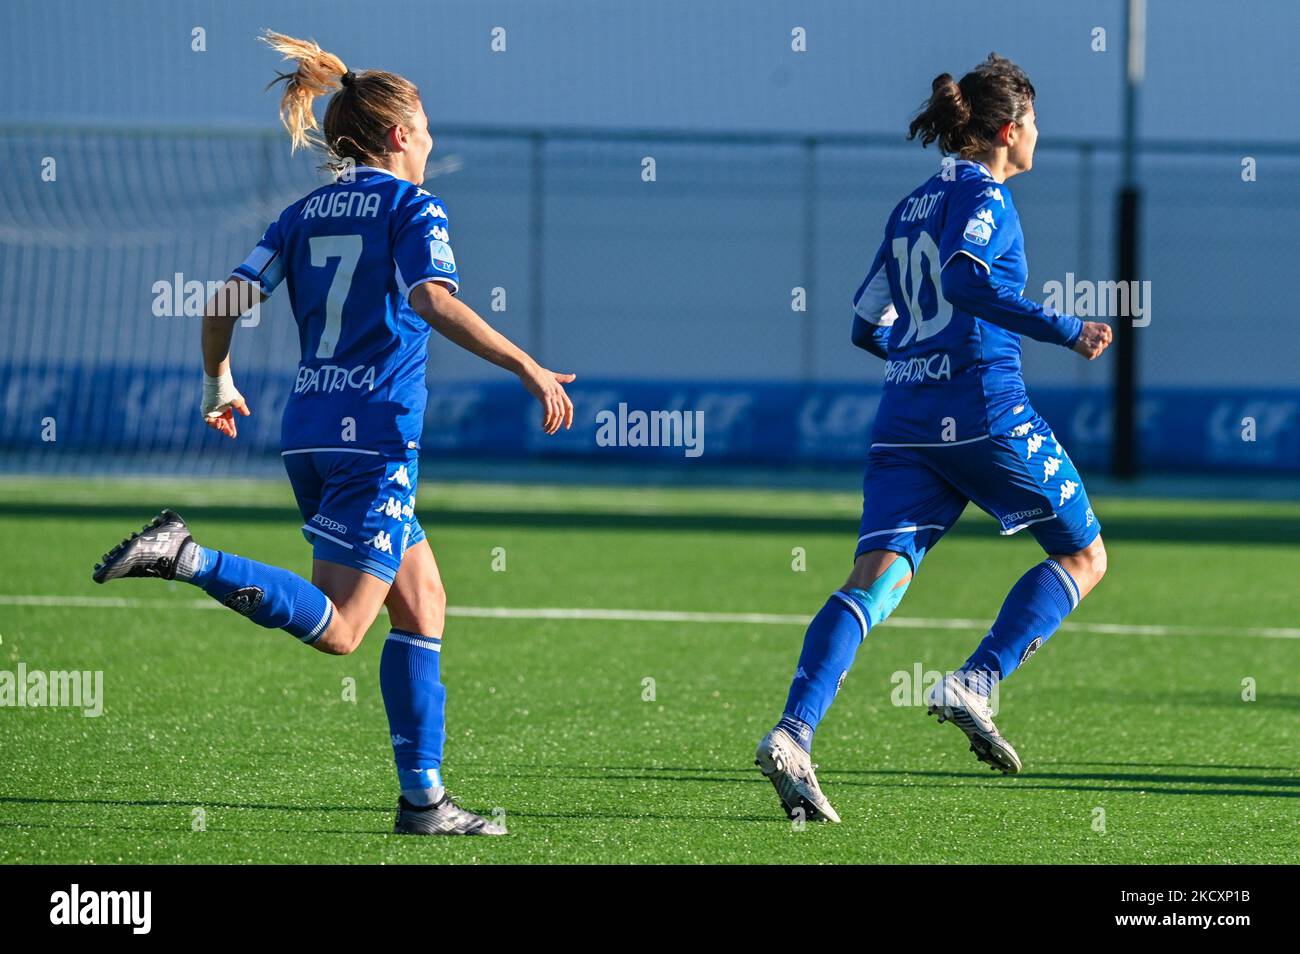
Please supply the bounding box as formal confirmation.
[0,364,1300,474]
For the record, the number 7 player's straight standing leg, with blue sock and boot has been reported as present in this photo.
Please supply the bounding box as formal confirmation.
[380,539,506,834]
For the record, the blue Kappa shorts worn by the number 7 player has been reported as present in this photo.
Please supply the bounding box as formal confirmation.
[283,451,425,584]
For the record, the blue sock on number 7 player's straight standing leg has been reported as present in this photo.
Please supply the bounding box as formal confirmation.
[380,629,447,806]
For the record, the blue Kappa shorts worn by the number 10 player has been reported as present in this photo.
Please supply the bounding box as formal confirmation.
[854,415,1101,572]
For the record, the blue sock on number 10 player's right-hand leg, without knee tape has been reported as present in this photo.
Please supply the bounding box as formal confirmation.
[961,560,1079,695]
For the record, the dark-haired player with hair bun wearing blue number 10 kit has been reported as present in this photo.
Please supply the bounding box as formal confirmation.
[755,53,1110,821]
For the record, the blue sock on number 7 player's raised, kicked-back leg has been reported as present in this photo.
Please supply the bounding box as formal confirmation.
[176,541,334,645]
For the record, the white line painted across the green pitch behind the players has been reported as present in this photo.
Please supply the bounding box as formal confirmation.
[0,594,1300,639]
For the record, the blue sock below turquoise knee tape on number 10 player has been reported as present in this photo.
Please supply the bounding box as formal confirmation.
[777,590,870,751]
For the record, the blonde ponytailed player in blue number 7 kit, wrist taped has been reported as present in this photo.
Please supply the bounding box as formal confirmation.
[94,31,575,834]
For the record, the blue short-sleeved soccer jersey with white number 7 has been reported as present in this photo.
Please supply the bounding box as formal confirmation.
[234,166,459,454]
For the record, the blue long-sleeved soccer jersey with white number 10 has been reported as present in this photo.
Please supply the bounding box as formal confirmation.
[854,160,1082,443]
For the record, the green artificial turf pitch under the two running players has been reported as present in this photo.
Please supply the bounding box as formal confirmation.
[0,478,1300,863]
